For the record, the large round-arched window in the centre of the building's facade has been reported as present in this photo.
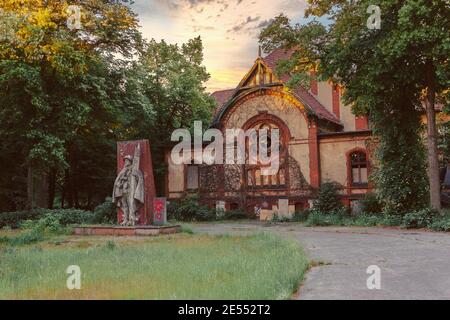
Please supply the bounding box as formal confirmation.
[245,120,287,189]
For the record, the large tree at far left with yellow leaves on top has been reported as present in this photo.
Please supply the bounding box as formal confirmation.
[0,0,140,207]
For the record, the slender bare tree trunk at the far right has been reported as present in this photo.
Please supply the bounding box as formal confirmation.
[425,62,441,210]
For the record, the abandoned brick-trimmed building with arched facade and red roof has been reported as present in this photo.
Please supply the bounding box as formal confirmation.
[166,49,371,218]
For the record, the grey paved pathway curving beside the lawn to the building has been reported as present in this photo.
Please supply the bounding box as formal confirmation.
[193,222,450,299]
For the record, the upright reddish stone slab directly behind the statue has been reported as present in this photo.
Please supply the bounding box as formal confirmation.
[117,140,156,226]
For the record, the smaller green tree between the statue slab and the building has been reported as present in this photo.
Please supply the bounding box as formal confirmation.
[134,37,214,191]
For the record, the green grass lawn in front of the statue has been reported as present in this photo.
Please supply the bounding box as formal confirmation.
[0,231,308,299]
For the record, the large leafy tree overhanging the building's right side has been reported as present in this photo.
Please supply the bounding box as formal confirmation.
[260,0,450,211]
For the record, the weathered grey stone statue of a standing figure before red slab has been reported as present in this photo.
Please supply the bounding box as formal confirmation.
[112,145,144,226]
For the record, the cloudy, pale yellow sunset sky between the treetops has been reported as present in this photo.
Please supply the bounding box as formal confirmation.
[133,0,306,92]
